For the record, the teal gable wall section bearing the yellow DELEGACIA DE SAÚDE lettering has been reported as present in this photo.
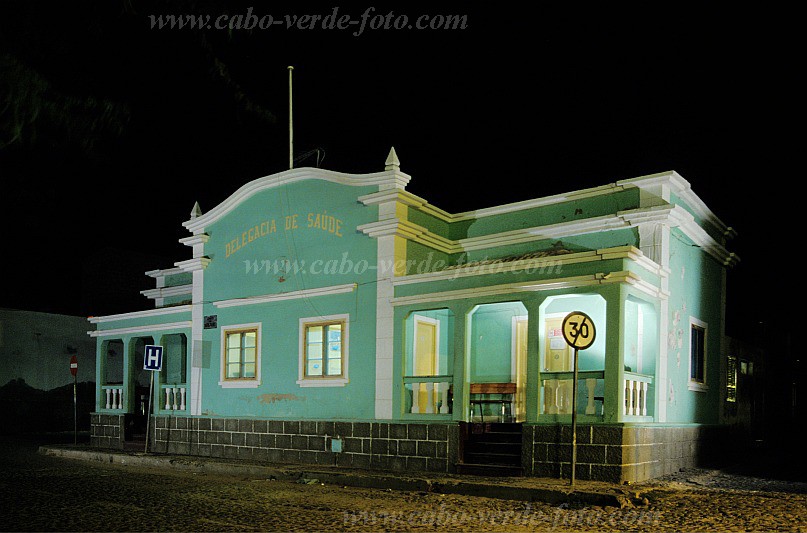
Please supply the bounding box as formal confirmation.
[204,180,378,301]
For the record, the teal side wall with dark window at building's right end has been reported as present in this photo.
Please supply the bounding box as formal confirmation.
[664,229,723,423]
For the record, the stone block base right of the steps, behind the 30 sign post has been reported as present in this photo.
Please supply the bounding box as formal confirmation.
[522,424,723,483]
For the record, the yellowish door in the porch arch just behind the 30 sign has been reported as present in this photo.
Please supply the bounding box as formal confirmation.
[543,315,572,414]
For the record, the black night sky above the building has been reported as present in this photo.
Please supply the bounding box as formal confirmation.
[0,0,803,333]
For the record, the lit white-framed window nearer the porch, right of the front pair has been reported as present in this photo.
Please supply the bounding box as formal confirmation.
[297,315,349,387]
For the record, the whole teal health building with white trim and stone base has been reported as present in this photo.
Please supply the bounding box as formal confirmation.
[90,150,736,481]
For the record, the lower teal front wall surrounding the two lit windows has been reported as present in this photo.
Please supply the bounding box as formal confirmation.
[202,285,376,420]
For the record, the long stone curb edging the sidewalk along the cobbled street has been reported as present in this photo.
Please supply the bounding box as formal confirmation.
[38,446,631,508]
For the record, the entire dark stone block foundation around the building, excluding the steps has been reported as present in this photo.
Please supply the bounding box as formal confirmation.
[90,413,728,483]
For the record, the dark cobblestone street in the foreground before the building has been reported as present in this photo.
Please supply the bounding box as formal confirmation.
[0,438,807,531]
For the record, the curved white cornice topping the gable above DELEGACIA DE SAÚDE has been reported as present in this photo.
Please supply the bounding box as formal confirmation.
[182,167,411,234]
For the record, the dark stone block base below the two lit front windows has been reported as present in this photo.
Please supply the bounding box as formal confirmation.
[144,416,459,472]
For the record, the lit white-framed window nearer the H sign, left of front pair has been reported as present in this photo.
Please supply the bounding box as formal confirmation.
[219,324,261,388]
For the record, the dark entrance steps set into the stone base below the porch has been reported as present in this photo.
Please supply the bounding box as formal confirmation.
[456,422,524,477]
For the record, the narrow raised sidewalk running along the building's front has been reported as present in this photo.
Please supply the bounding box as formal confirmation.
[39,445,642,508]
